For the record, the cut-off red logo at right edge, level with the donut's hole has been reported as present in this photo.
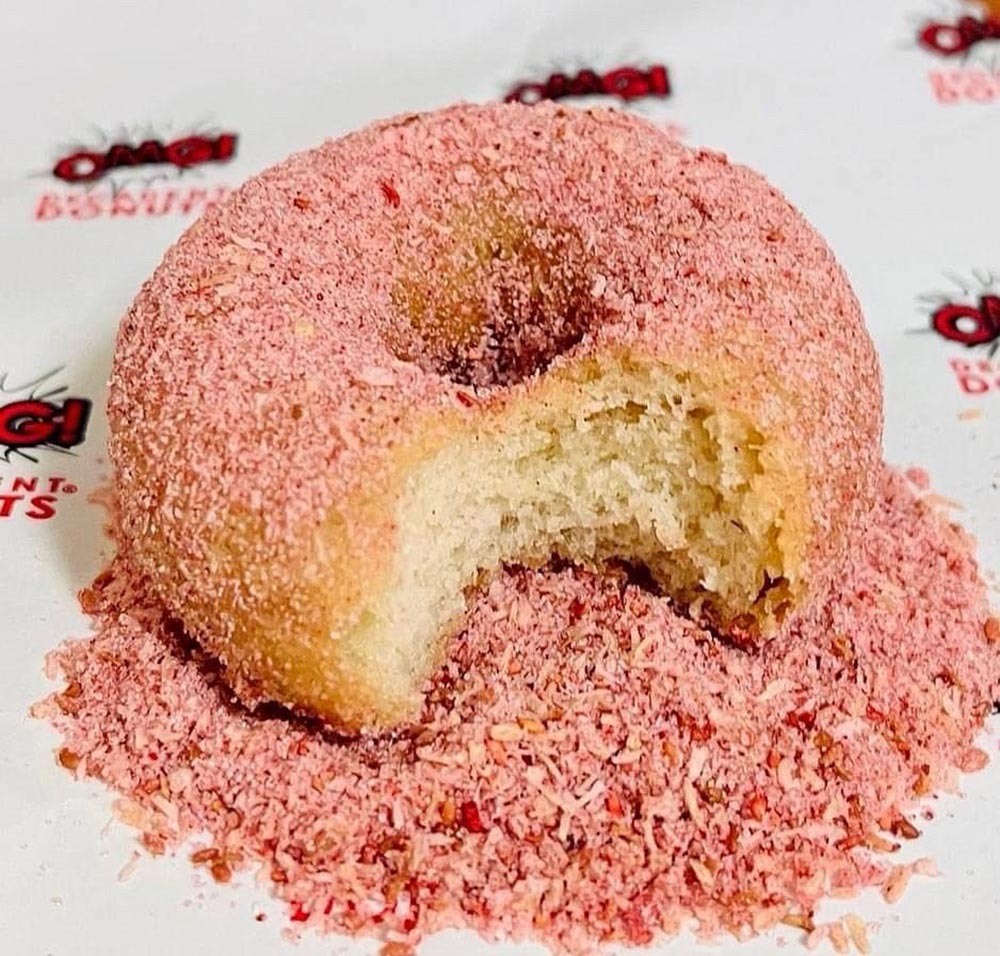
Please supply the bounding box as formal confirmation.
[919,270,1000,395]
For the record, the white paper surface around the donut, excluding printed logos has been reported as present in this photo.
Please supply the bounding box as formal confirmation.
[0,0,1000,956]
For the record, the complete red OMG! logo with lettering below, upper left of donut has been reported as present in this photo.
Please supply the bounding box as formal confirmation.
[35,119,239,222]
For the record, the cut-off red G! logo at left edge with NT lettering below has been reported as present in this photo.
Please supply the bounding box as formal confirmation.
[0,367,91,521]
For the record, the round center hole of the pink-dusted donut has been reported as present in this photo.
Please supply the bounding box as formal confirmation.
[387,203,595,389]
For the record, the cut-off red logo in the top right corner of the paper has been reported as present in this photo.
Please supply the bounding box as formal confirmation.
[916,0,1000,104]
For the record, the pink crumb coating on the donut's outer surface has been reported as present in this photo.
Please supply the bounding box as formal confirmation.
[109,103,882,646]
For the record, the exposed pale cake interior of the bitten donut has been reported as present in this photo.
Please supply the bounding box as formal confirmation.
[364,355,810,696]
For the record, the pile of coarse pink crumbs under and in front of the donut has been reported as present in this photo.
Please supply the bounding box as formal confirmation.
[36,471,1000,952]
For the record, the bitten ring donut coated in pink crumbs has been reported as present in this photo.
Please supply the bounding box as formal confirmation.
[109,103,882,731]
